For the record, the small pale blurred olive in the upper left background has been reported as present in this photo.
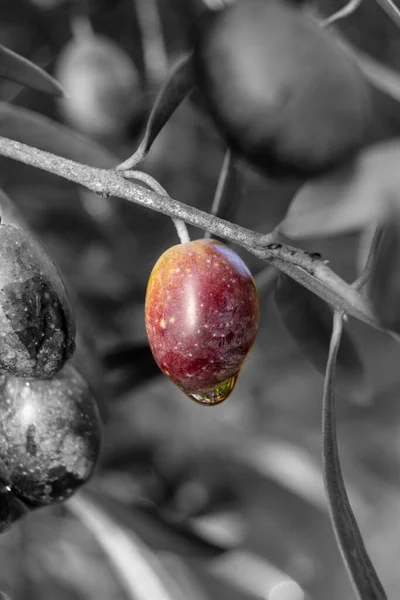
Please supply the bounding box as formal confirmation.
[56,31,143,137]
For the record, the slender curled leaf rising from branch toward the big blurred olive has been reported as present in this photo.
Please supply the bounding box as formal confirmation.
[117,55,194,171]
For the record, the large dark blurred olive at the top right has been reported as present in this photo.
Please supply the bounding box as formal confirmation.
[194,0,372,179]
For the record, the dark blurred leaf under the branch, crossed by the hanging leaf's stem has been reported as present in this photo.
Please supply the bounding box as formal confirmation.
[275,275,363,385]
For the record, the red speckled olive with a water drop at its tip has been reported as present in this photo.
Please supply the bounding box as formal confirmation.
[145,239,259,405]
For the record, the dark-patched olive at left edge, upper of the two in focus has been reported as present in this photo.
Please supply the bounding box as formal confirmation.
[0,224,75,378]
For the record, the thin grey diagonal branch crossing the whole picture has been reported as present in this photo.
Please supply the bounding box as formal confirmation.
[0,136,398,339]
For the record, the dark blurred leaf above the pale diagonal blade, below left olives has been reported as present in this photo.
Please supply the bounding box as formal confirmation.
[79,492,225,558]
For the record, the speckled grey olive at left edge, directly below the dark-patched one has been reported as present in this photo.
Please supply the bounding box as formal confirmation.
[0,364,101,508]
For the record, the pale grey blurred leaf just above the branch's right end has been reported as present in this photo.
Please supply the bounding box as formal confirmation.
[278,162,384,239]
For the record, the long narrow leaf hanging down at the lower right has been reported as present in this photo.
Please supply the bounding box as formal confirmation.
[322,312,387,600]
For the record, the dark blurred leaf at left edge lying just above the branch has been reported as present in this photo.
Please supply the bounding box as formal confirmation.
[0,102,118,169]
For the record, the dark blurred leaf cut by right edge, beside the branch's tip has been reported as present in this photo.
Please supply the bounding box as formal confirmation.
[368,213,400,333]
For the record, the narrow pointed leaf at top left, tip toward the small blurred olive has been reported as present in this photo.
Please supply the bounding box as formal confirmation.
[0,44,64,96]
